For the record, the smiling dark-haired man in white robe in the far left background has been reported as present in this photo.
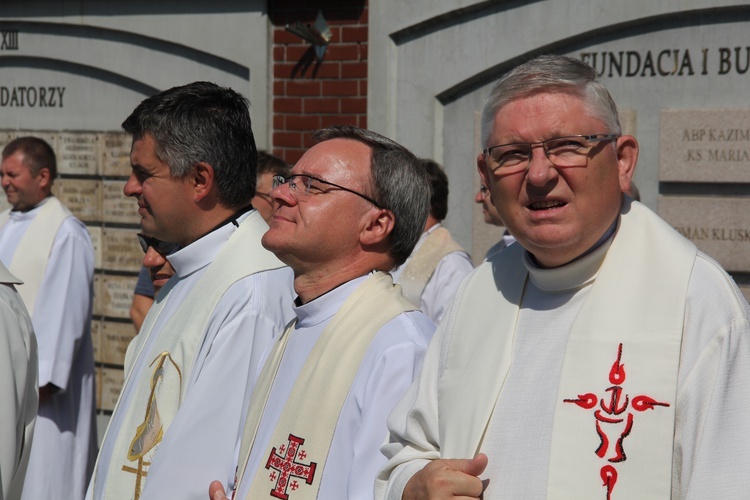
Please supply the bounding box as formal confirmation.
[0,137,97,500]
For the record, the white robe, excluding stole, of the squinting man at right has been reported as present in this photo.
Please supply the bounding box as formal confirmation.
[378,201,750,500]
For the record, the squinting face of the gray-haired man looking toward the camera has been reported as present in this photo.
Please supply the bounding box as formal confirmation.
[477,92,638,267]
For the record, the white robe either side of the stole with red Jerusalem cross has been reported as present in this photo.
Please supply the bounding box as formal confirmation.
[232,277,435,499]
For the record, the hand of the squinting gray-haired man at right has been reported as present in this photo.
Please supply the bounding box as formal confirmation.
[406,453,487,500]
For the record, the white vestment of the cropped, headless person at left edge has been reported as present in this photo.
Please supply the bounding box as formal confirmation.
[0,263,39,500]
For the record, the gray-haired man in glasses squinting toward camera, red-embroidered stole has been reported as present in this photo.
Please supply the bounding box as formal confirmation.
[376,56,750,499]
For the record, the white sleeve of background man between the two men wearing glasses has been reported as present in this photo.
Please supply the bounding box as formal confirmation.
[419,252,474,325]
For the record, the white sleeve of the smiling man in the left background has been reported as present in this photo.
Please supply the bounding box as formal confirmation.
[32,217,94,391]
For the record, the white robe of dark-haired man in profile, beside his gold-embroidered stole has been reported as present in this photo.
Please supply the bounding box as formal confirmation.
[87,211,294,500]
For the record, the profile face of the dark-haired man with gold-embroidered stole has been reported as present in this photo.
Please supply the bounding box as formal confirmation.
[123,135,194,246]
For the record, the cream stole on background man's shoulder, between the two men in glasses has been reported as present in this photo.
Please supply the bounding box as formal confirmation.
[398,227,465,307]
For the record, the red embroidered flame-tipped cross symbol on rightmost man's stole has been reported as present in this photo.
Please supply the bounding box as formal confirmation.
[563,344,669,500]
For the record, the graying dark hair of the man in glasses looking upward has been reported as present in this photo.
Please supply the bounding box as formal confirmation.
[313,125,430,266]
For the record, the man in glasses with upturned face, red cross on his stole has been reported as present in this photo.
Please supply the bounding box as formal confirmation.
[211,127,434,500]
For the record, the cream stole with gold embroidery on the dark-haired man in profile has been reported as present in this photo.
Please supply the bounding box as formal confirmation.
[94,212,284,500]
